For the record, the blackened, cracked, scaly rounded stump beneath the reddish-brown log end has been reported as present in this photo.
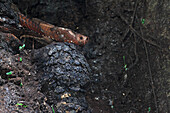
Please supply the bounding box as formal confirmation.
[33,43,90,113]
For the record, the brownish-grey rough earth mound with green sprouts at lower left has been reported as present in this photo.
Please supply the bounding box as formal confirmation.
[0,46,52,113]
